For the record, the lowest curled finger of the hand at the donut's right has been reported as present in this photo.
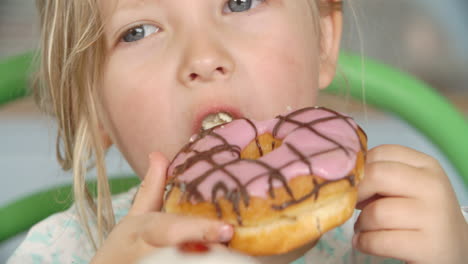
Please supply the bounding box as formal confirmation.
[353,230,427,262]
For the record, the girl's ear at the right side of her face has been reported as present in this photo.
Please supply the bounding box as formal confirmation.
[319,0,343,89]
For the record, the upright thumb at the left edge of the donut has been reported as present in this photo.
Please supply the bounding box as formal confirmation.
[129,152,169,215]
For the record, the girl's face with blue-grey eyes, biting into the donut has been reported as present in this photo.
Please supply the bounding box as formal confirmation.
[99,0,340,176]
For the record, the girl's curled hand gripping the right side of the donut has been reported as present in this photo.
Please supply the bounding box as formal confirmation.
[353,145,468,264]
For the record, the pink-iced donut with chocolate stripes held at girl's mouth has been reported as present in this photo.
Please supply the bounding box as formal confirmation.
[163,107,367,256]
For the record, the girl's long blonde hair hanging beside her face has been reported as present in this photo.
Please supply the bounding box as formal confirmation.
[34,0,341,249]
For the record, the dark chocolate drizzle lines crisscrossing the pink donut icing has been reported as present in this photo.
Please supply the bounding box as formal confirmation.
[168,107,365,225]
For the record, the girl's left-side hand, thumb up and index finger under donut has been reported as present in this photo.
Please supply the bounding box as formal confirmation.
[92,154,233,264]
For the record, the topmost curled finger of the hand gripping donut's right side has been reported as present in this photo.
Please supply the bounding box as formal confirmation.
[366,145,440,171]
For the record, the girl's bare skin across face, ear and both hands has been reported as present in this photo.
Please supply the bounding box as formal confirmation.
[89,0,468,263]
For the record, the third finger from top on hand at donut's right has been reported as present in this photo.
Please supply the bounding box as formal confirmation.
[354,197,427,233]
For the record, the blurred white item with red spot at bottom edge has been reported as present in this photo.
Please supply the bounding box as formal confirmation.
[138,242,259,264]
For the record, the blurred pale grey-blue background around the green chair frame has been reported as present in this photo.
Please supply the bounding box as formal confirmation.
[0,0,468,263]
